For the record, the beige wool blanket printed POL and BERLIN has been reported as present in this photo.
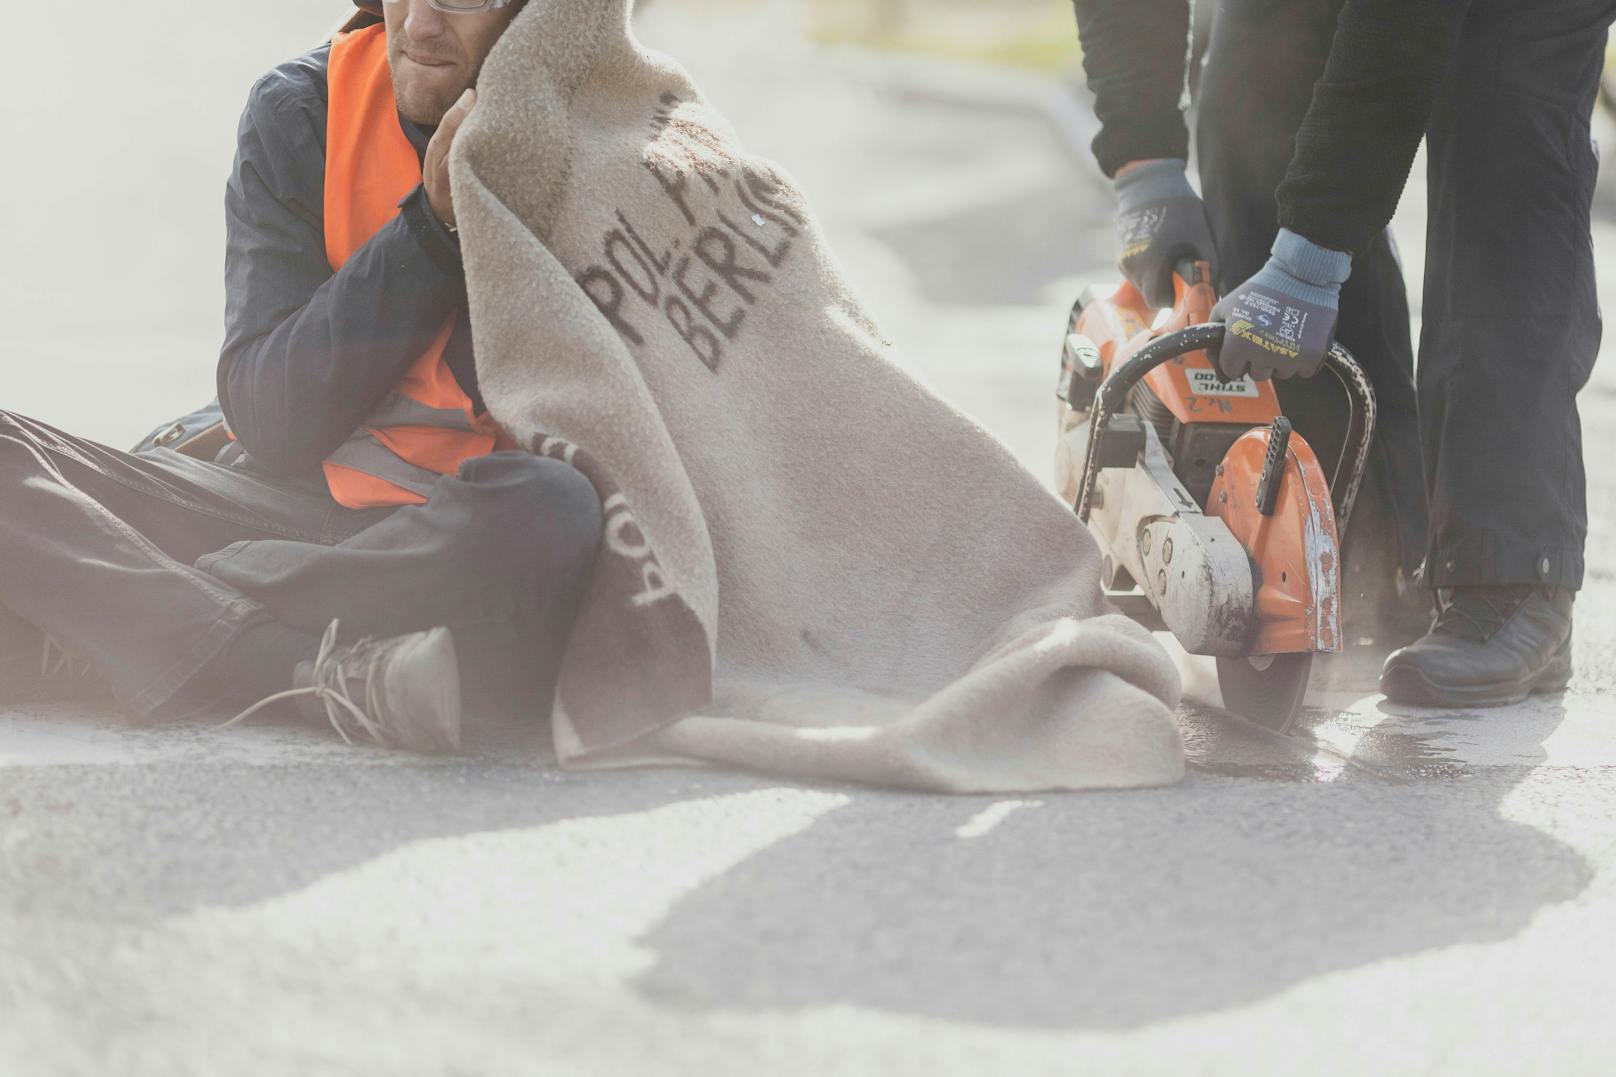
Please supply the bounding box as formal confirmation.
[452,0,1183,792]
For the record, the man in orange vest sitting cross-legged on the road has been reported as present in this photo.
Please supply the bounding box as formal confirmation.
[0,0,601,750]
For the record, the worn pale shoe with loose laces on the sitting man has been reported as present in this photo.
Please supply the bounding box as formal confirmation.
[221,621,461,752]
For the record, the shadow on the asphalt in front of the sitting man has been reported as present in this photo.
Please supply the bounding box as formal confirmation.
[0,734,777,927]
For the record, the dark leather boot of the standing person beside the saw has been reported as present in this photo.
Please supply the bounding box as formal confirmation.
[1380,584,1576,707]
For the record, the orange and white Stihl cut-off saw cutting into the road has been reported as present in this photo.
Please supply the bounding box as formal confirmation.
[1055,262,1375,733]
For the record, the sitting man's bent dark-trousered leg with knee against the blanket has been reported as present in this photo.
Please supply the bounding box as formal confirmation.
[197,453,603,716]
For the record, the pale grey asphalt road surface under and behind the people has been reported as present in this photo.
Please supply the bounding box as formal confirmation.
[0,0,1616,1077]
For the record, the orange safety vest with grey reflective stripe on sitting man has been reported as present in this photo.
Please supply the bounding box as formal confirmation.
[325,23,503,509]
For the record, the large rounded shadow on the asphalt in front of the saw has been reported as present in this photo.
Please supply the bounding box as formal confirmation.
[640,695,1592,1028]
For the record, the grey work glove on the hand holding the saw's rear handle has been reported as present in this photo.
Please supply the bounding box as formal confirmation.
[1115,158,1217,309]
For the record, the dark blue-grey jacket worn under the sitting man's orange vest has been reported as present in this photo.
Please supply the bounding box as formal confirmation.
[206,45,482,475]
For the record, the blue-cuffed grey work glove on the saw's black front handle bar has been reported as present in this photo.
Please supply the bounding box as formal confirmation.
[1212,228,1353,382]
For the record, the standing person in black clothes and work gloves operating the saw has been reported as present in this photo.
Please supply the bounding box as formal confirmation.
[1076,0,1616,705]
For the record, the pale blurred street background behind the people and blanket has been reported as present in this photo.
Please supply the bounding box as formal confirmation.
[9,0,1616,475]
